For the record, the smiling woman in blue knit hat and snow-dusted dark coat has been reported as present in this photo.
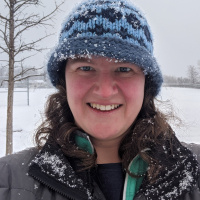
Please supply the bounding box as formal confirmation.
[0,0,200,200]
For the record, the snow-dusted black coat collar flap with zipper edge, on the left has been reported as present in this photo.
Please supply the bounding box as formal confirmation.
[28,143,92,200]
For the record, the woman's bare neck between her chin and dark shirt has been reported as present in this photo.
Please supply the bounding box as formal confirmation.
[91,138,121,164]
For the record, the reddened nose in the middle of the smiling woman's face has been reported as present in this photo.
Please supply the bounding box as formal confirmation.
[93,73,118,98]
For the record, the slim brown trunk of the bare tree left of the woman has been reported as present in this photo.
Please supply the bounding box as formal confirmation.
[6,0,14,155]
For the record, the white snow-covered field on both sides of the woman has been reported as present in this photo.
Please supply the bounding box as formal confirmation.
[0,87,200,157]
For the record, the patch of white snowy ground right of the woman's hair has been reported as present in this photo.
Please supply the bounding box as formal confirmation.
[159,87,200,144]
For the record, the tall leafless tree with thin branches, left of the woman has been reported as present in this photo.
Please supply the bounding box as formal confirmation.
[0,0,64,155]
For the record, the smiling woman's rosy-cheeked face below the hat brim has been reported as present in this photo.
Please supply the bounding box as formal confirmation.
[65,57,145,141]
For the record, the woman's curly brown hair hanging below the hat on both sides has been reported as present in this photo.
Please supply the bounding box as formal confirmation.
[35,71,173,182]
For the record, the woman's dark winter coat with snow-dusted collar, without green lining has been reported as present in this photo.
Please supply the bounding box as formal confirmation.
[0,138,200,200]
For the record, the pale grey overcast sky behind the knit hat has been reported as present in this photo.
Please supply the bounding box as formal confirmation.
[2,0,200,76]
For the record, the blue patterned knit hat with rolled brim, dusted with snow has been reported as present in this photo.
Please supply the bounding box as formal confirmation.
[47,0,163,96]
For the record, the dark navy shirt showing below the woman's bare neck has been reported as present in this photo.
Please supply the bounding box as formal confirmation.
[96,163,125,200]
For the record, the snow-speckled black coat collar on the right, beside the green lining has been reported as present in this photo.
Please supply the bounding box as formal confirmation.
[139,136,199,200]
